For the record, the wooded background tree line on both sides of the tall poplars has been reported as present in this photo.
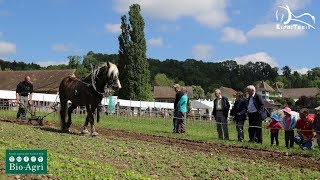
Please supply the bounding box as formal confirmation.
[0,54,320,92]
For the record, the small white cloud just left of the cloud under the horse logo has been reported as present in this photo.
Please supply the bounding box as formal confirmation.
[221,27,247,44]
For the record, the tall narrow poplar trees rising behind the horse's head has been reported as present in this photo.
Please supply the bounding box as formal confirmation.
[118,4,152,100]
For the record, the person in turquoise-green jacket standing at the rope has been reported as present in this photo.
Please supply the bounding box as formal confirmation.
[177,87,188,133]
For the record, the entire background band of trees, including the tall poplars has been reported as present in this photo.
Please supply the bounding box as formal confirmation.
[0,4,320,104]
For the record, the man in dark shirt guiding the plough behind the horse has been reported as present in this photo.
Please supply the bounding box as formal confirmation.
[16,76,33,121]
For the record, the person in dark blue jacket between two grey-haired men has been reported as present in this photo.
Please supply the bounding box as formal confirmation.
[230,91,247,142]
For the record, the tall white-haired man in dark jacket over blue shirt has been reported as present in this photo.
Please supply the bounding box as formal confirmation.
[247,85,264,144]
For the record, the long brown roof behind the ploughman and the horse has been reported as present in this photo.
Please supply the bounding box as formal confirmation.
[0,69,76,93]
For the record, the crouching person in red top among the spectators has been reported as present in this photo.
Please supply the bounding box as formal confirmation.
[294,108,315,150]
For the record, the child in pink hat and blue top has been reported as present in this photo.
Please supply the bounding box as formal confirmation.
[282,107,297,149]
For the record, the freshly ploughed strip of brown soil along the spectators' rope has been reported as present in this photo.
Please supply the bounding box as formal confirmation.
[0,117,320,171]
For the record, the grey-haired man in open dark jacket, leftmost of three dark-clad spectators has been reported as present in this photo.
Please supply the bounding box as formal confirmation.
[212,89,230,140]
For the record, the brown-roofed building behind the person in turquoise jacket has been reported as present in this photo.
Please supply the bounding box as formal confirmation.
[153,86,193,103]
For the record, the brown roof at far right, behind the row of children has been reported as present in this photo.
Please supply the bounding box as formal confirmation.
[282,87,320,99]
